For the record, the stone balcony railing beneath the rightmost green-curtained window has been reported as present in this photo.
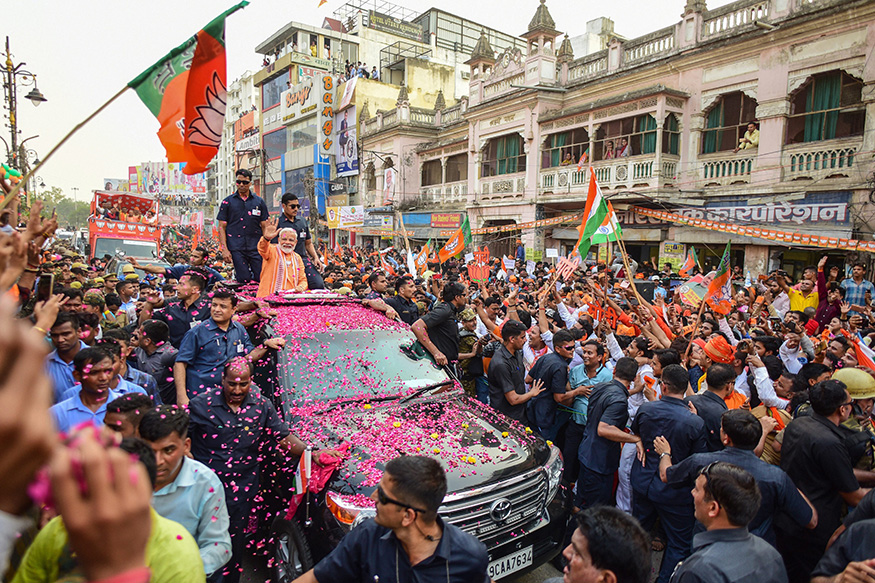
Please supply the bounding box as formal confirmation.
[781,137,863,180]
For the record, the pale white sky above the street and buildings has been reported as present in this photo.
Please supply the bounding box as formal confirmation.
[8,0,729,200]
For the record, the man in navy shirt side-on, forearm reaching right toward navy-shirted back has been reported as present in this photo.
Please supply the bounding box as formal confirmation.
[574,356,641,508]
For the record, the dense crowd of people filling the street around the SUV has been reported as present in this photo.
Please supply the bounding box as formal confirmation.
[0,165,875,583]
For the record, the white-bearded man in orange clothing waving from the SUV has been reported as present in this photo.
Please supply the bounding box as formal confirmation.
[256,219,307,298]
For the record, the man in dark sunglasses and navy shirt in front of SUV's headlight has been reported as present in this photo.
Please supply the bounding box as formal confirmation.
[295,455,490,583]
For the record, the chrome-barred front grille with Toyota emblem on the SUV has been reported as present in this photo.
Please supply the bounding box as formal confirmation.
[438,468,547,547]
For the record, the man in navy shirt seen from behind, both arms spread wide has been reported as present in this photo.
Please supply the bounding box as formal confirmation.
[653,409,817,546]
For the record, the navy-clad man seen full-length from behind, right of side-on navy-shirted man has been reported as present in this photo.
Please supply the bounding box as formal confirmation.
[631,364,707,583]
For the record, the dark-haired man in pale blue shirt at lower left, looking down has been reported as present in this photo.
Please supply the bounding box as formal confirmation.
[140,405,231,575]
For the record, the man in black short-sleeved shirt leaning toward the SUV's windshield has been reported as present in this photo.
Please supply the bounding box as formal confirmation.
[410,282,468,374]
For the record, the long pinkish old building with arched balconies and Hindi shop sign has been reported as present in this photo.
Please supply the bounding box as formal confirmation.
[361,0,875,272]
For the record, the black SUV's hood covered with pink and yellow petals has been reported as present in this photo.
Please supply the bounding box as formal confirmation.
[289,390,549,495]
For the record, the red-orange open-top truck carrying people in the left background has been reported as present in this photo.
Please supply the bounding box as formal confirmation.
[88,190,161,264]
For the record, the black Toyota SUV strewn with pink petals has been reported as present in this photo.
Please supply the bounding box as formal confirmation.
[260,296,568,582]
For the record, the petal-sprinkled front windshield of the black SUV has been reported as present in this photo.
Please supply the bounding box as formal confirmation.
[280,329,447,404]
